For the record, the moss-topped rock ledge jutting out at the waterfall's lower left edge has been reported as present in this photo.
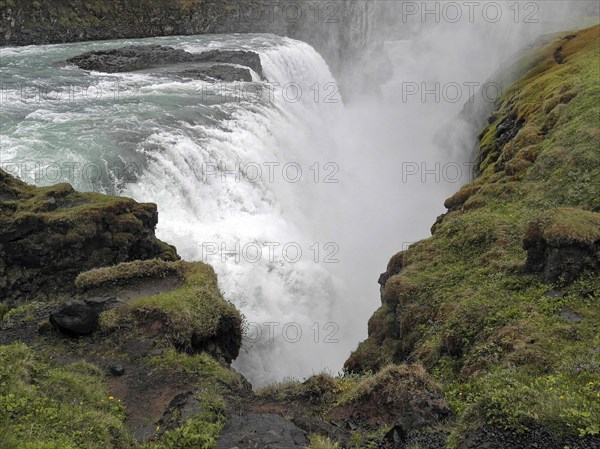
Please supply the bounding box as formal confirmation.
[90,260,242,363]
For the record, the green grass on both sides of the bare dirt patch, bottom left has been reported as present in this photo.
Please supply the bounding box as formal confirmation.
[0,343,241,449]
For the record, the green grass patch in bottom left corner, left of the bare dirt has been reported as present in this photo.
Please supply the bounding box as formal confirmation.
[0,344,132,449]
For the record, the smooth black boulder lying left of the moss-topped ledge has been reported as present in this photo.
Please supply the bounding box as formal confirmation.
[50,298,117,336]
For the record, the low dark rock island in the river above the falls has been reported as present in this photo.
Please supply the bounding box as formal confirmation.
[67,45,262,81]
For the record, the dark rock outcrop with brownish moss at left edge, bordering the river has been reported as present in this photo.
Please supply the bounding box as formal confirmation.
[0,170,179,302]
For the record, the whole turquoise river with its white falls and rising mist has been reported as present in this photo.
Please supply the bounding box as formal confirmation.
[0,0,596,386]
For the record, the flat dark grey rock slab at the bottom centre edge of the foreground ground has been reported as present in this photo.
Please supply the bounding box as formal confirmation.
[217,413,308,449]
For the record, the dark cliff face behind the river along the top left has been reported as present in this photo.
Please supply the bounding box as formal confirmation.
[0,0,279,46]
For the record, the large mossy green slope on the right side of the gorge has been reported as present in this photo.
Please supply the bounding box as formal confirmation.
[346,22,600,435]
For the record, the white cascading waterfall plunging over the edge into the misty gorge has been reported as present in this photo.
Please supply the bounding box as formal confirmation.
[124,39,350,385]
